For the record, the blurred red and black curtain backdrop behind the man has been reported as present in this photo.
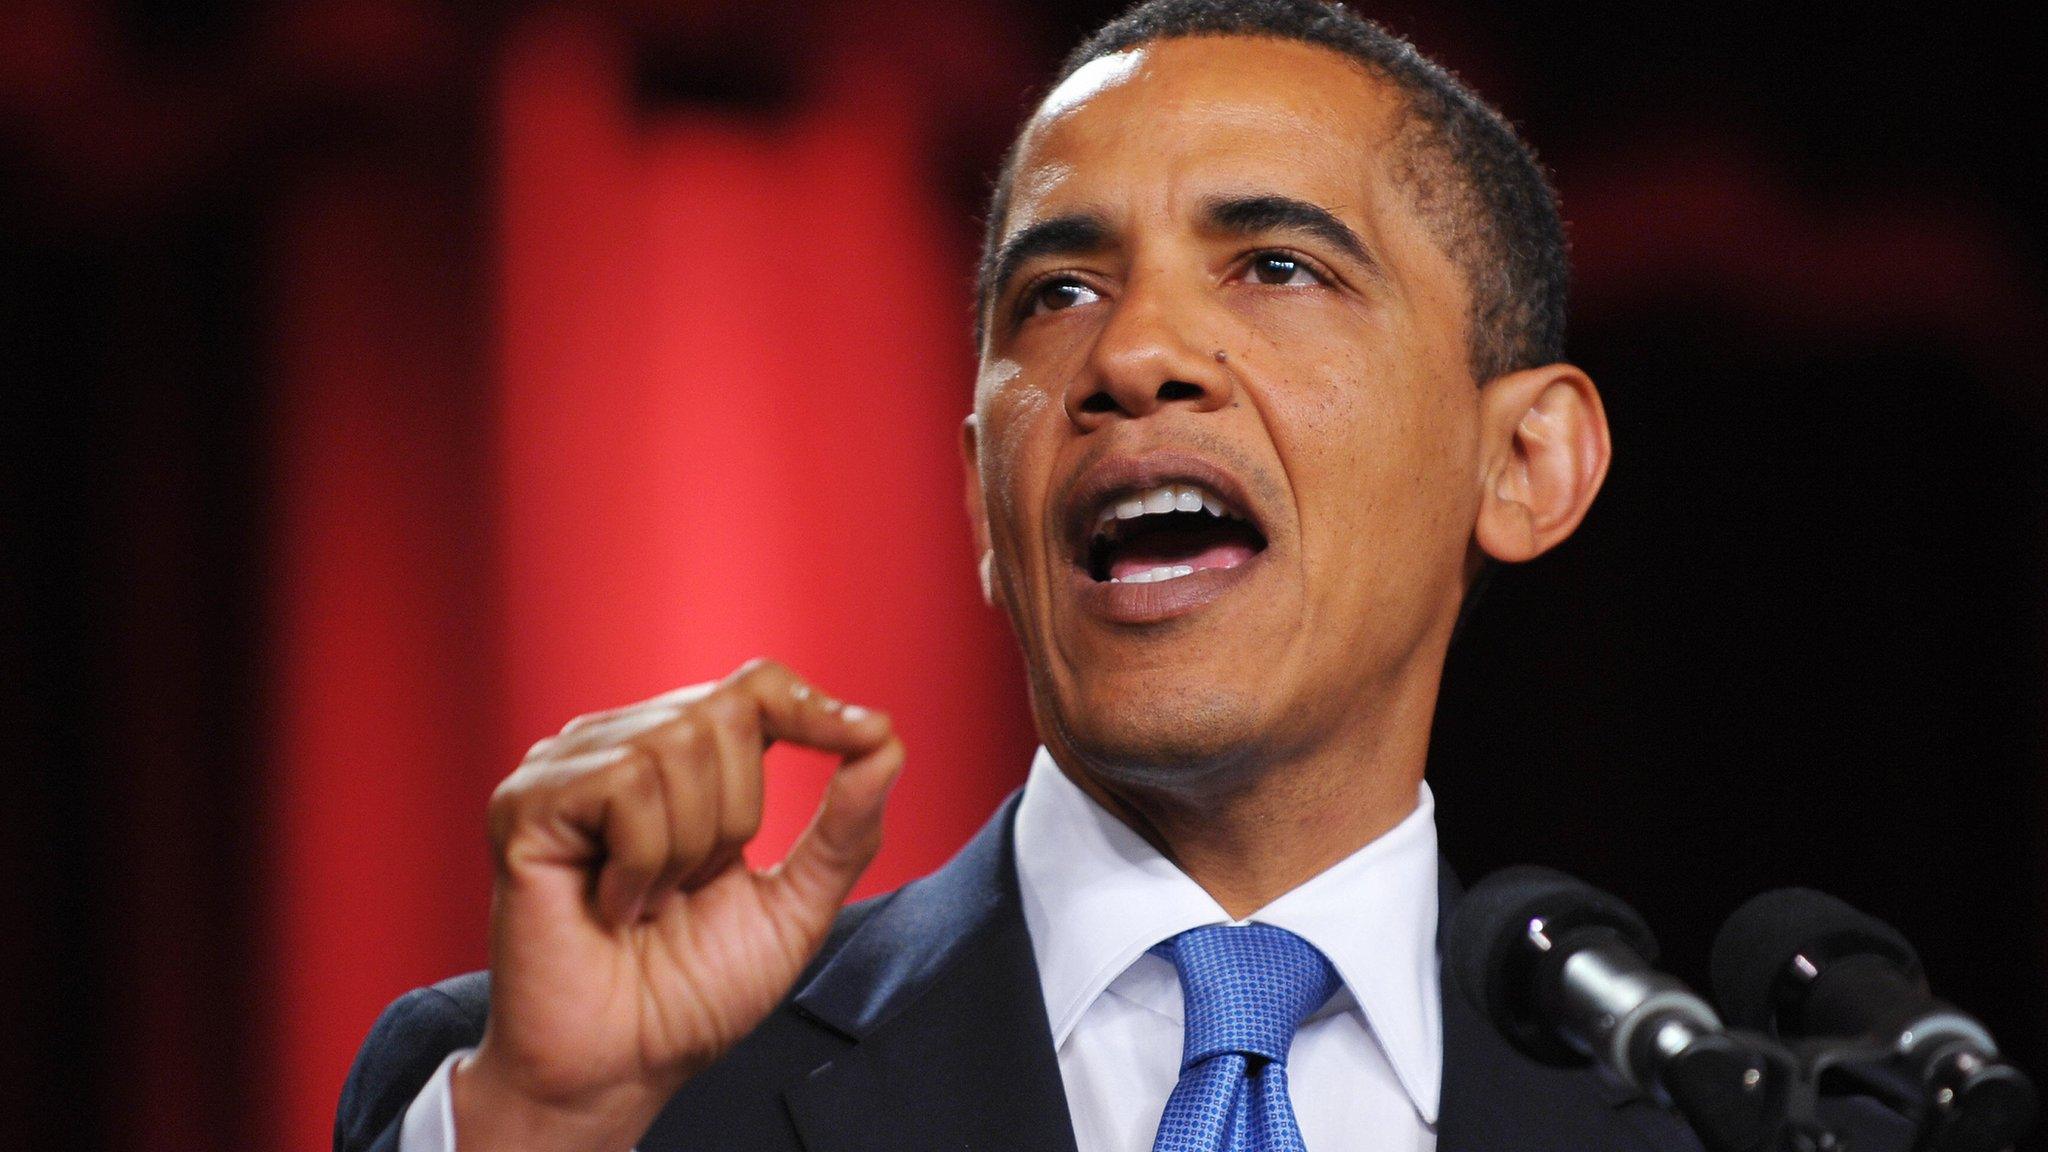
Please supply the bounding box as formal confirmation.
[0,0,2048,1150]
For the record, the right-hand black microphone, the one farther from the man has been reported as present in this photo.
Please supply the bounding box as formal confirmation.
[1710,888,2038,1152]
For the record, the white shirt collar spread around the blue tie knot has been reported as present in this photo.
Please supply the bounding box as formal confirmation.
[1016,748,1444,1123]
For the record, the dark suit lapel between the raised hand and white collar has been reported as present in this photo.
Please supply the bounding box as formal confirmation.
[784,797,1073,1152]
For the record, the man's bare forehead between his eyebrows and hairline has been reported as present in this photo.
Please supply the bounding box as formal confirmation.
[1004,37,1403,232]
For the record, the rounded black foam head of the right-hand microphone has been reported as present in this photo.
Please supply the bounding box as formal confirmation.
[1708,888,1921,1033]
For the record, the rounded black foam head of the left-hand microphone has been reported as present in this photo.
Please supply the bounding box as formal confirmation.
[1444,865,1657,1066]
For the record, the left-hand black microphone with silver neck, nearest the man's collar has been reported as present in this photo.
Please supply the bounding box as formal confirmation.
[1444,865,1784,1152]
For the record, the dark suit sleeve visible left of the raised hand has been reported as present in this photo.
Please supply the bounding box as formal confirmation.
[334,972,489,1152]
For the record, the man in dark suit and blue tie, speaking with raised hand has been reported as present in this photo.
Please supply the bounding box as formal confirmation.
[336,0,1900,1152]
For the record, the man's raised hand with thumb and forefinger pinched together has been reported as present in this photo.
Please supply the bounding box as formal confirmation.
[453,660,903,1152]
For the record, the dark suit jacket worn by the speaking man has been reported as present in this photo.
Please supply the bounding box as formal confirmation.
[334,797,1907,1152]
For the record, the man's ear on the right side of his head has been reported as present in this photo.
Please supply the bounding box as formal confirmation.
[1473,365,1614,564]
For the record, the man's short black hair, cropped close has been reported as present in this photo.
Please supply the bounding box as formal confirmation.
[975,0,1571,383]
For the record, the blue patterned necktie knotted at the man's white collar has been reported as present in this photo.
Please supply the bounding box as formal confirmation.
[1153,924,1341,1152]
